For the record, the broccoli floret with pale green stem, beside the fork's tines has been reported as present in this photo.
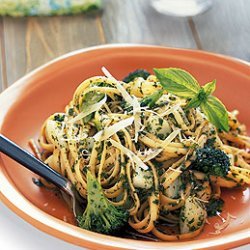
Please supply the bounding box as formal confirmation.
[77,171,128,234]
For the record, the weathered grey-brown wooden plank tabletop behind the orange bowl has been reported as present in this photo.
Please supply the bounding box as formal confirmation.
[0,0,250,89]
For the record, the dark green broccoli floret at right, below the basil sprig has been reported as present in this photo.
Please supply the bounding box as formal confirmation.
[192,146,230,177]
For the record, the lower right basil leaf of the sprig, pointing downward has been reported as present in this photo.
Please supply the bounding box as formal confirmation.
[201,95,229,132]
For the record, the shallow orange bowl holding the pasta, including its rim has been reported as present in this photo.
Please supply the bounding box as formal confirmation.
[0,45,250,249]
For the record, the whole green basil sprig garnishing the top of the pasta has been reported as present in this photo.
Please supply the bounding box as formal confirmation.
[154,68,229,131]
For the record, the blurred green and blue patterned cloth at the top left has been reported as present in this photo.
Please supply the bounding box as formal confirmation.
[0,0,101,17]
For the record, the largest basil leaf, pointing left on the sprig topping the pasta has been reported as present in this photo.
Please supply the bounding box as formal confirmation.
[154,68,200,98]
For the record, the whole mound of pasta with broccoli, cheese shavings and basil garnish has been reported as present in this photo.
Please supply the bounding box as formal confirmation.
[36,68,250,241]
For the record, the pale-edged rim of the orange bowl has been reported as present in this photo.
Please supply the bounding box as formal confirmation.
[0,43,250,249]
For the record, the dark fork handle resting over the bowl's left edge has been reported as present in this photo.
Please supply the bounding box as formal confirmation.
[0,134,71,189]
